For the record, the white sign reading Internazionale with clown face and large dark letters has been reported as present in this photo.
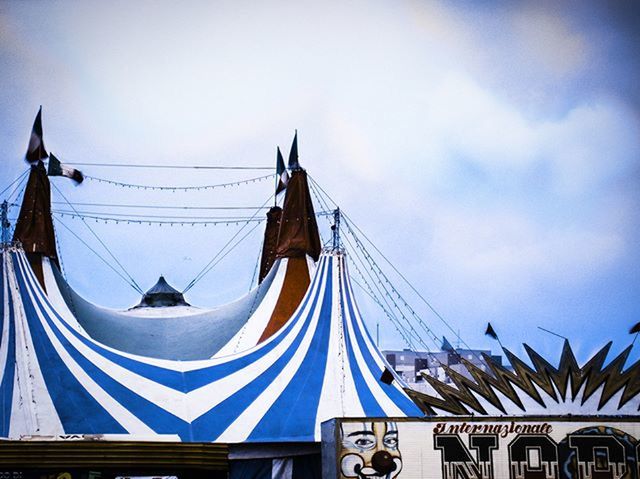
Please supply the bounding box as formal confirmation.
[322,416,640,479]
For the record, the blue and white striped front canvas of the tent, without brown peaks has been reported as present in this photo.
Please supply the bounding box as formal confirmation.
[0,248,422,443]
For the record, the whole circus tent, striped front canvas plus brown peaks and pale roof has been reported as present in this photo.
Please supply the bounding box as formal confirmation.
[0,143,421,443]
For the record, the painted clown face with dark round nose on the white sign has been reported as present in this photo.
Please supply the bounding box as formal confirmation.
[340,422,402,479]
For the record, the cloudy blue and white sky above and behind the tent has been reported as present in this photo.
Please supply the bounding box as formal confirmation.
[0,0,640,360]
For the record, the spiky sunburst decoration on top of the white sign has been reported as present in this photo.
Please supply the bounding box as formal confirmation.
[406,341,640,415]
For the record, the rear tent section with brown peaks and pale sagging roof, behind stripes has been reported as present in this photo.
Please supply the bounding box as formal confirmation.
[14,164,320,360]
